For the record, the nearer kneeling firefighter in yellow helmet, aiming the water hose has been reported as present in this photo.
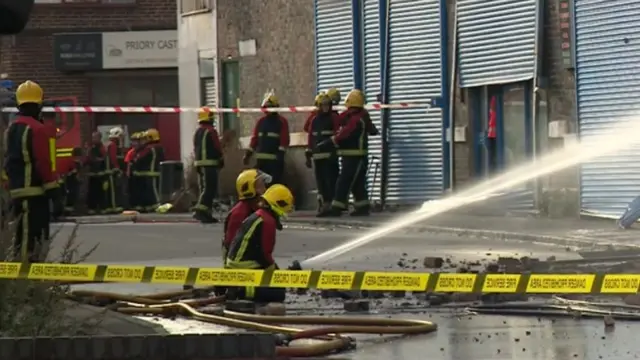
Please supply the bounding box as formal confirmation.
[225,184,293,303]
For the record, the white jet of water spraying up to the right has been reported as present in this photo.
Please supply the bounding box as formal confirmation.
[302,117,640,268]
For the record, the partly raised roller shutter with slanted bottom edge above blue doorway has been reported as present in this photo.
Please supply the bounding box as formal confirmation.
[457,0,540,87]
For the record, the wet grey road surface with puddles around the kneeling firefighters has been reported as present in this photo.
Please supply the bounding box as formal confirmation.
[52,224,640,360]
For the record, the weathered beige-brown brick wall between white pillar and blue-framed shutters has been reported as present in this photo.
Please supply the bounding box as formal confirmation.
[217,0,315,135]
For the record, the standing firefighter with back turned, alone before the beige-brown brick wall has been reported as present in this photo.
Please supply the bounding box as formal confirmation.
[243,92,290,184]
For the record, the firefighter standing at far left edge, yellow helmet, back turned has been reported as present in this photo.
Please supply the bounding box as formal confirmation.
[4,81,63,262]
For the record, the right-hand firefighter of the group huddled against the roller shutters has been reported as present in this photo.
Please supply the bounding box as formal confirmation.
[314,89,370,216]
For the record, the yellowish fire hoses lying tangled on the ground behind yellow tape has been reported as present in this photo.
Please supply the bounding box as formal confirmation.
[70,289,437,357]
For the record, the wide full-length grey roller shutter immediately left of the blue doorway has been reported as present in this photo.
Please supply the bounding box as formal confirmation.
[387,0,444,205]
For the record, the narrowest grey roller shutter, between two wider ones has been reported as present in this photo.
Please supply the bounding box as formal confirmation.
[362,0,382,201]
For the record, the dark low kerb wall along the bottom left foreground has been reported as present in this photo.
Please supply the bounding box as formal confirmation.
[0,333,276,360]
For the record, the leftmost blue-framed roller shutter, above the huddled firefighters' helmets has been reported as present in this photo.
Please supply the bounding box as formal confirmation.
[315,0,353,95]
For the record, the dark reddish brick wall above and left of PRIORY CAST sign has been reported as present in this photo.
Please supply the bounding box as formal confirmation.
[0,0,176,103]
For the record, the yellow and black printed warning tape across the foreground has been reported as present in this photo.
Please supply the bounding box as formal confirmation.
[0,262,640,294]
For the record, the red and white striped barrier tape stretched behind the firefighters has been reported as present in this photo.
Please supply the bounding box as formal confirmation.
[2,103,431,114]
